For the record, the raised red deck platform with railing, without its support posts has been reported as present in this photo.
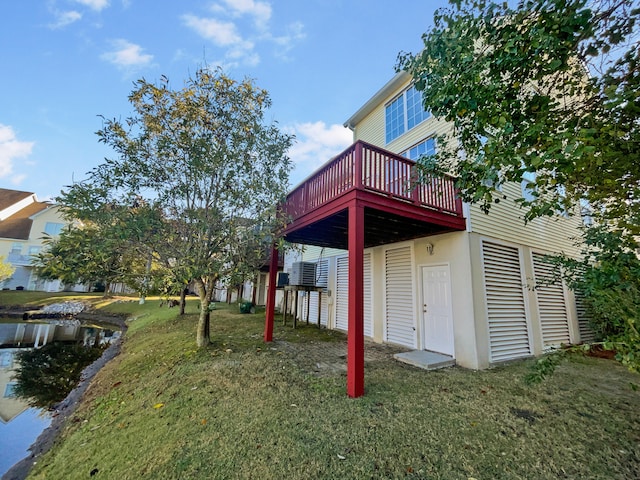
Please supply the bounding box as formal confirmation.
[282,141,465,249]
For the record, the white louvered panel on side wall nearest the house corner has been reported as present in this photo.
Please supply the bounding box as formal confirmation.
[482,241,531,362]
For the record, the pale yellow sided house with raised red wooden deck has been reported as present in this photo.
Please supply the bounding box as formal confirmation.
[265,72,590,397]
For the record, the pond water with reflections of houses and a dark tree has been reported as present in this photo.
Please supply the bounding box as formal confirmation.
[0,318,120,476]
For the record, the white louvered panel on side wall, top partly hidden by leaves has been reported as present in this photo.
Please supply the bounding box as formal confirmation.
[532,252,571,346]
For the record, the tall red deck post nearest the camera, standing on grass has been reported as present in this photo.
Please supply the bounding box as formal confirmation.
[347,200,364,398]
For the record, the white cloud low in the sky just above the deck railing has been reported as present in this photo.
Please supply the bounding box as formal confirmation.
[286,122,353,183]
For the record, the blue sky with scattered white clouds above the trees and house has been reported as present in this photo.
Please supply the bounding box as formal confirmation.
[0,0,446,200]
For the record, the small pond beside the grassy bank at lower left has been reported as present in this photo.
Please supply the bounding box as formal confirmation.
[0,317,120,476]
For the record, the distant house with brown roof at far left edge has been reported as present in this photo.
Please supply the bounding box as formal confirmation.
[0,188,68,292]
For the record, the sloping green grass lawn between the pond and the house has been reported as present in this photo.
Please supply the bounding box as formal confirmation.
[5,292,640,480]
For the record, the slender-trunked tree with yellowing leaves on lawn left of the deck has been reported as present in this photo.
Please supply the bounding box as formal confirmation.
[58,68,292,346]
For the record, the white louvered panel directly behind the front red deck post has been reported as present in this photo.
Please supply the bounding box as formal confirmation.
[336,253,373,337]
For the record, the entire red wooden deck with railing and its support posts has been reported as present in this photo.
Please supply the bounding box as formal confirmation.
[264,142,465,397]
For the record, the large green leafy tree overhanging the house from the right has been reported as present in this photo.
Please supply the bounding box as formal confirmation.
[397,0,640,374]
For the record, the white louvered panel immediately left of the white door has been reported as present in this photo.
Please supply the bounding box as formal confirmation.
[385,247,416,348]
